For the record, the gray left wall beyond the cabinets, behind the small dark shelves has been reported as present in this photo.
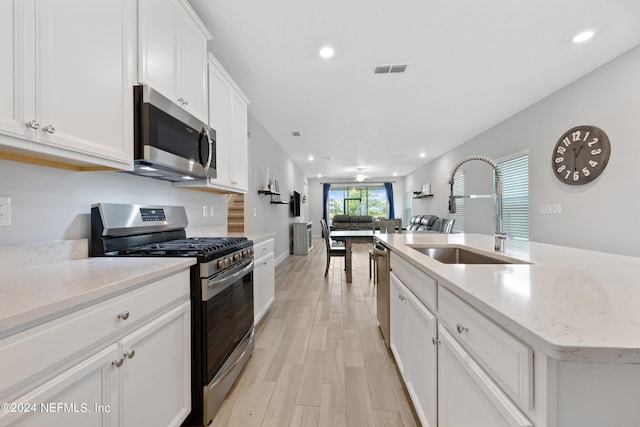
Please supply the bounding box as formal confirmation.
[245,113,309,261]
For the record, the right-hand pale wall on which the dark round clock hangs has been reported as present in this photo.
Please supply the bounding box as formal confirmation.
[406,47,640,256]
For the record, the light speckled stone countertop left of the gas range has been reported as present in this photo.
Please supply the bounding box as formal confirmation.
[0,254,195,338]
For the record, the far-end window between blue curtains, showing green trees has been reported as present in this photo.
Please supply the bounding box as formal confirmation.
[328,185,389,220]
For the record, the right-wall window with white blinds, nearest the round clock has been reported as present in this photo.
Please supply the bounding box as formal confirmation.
[498,154,529,240]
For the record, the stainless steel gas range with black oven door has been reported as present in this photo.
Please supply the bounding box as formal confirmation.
[89,203,254,426]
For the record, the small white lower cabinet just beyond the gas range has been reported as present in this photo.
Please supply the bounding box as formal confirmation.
[253,239,275,325]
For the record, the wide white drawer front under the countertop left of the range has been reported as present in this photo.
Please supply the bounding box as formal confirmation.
[0,270,189,396]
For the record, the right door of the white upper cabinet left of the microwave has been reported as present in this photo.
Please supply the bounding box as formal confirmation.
[33,0,135,164]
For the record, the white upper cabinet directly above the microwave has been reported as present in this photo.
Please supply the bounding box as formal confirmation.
[138,0,211,122]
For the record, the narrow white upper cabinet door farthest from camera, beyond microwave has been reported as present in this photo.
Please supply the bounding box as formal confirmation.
[230,92,249,191]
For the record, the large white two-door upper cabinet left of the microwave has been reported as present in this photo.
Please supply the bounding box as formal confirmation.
[0,0,135,169]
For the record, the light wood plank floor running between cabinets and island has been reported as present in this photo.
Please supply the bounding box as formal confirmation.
[212,239,420,427]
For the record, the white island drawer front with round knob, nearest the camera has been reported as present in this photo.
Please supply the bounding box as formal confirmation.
[438,287,533,410]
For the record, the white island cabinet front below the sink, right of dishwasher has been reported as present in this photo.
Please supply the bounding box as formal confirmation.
[390,273,437,427]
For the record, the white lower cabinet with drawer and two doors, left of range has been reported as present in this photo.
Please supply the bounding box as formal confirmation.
[0,270,191,427]
